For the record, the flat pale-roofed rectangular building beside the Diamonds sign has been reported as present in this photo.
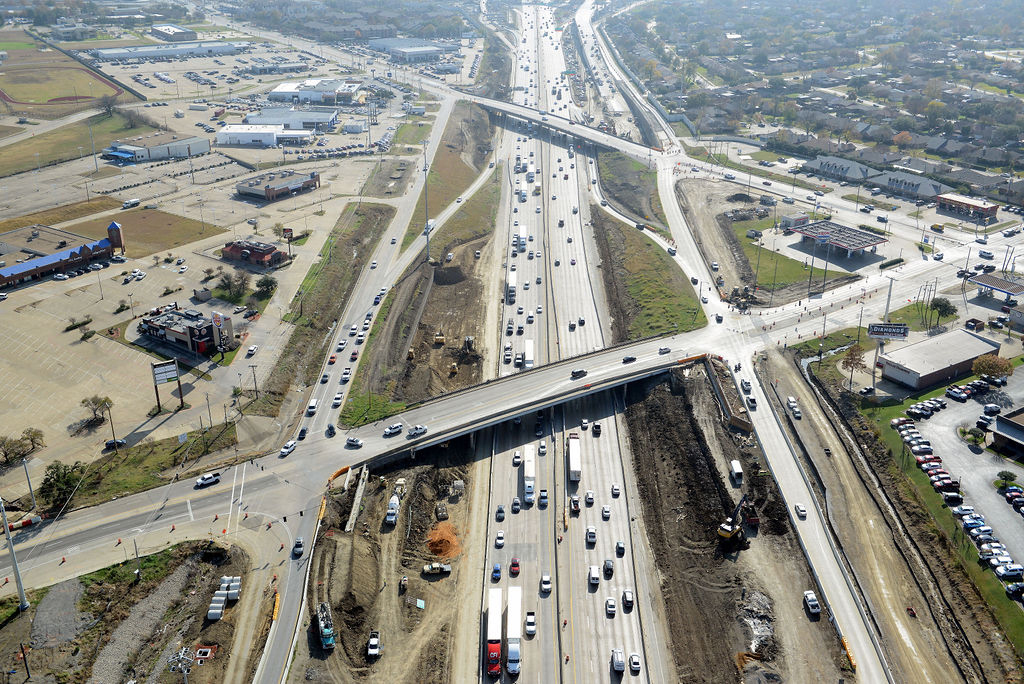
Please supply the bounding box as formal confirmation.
[879,329,999,389]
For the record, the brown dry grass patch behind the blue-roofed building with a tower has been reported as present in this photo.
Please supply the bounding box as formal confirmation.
[68,209,224,258]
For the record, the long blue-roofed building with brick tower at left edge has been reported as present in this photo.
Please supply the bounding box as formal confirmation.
[0,222,124,288]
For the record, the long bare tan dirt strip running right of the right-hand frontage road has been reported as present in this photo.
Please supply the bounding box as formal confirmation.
[759,350,975,683]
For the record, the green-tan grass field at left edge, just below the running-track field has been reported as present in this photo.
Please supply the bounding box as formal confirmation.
[0,114,155,176]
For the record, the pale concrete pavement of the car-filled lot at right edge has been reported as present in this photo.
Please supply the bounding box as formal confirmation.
[901,377,1024,581]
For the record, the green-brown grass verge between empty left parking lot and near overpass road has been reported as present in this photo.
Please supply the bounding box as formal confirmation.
[66,421,238,508]
